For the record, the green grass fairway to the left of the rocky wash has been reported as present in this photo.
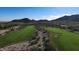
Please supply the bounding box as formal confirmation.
[0,26,36,47]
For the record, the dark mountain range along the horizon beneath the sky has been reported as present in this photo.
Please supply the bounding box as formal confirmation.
[11,14,79,22]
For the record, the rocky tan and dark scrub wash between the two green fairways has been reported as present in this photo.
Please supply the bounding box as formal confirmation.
[0,30,55,51]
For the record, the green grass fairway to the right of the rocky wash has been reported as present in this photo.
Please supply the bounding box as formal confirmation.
[46,27,79,51]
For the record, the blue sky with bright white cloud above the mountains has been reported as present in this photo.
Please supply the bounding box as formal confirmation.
[0,7,79,21]
